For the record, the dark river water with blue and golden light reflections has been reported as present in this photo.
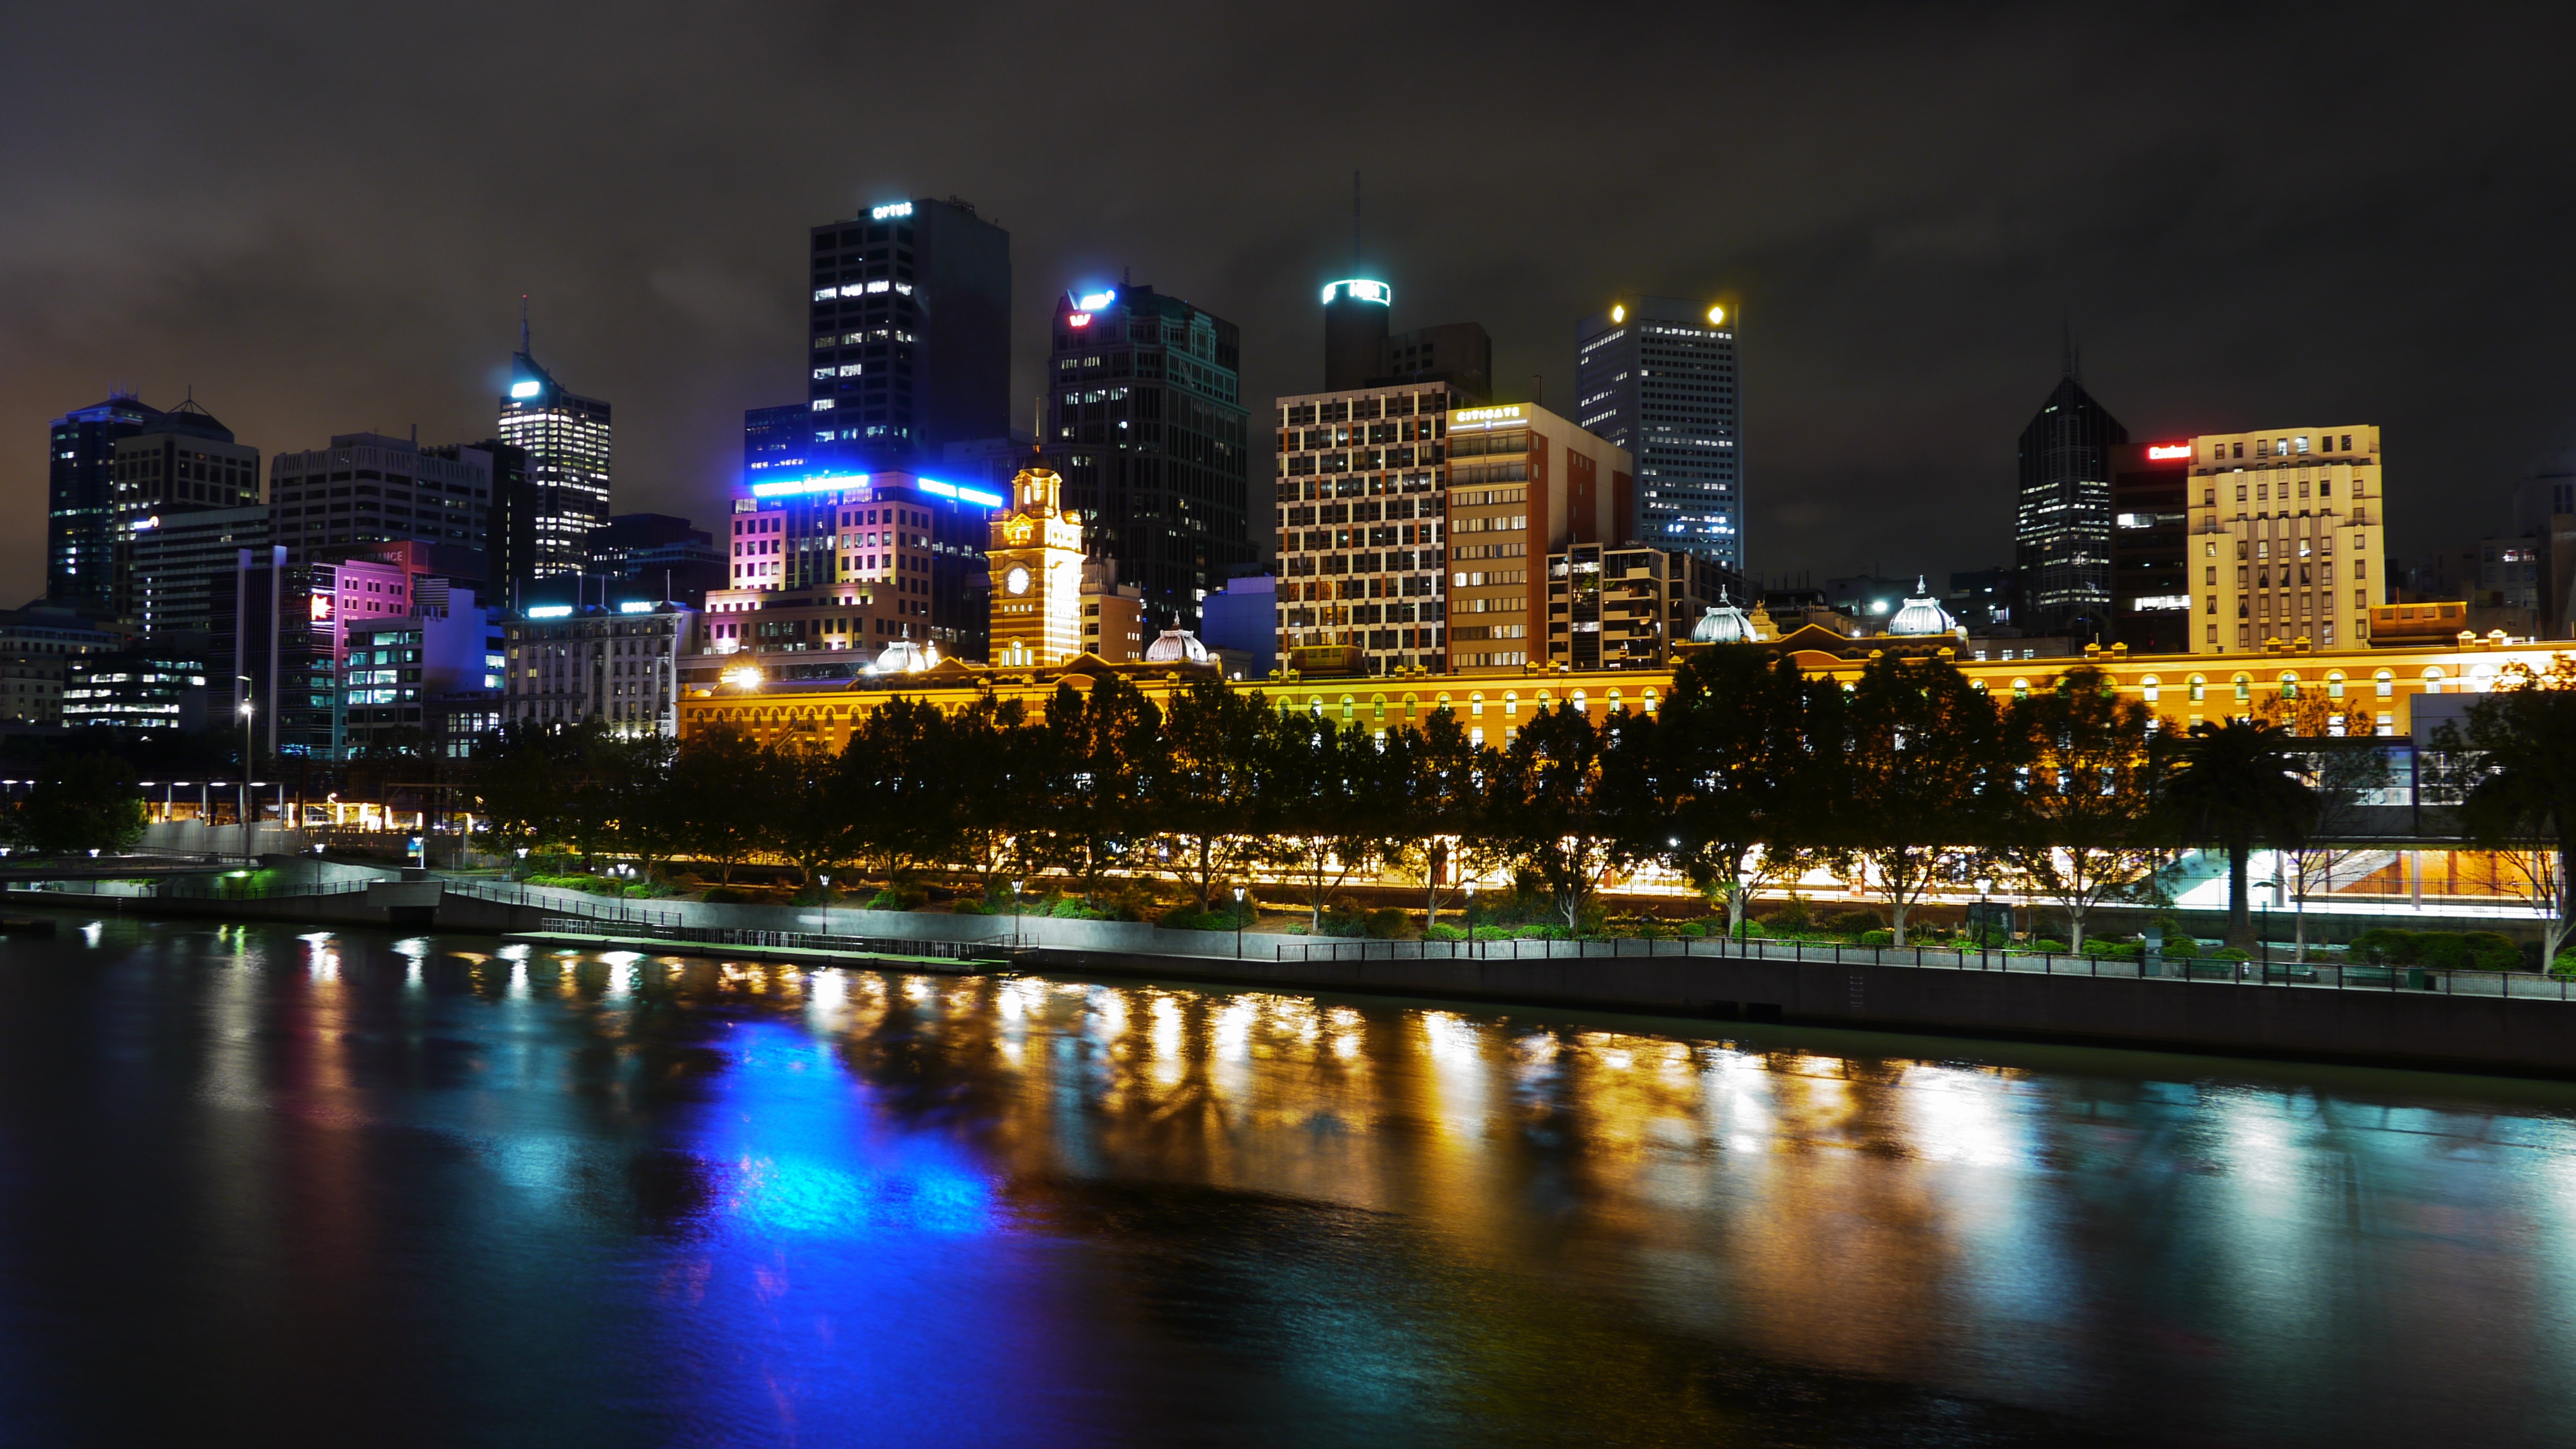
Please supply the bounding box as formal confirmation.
[0,915,2576,1447]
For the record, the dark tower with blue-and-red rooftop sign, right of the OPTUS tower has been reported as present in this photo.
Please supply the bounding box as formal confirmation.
[1046,286,1252,629]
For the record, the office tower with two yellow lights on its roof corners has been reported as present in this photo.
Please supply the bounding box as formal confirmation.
[1574,297,1744,572]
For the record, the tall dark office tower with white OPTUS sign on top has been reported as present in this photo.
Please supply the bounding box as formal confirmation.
[806,196,1010,472]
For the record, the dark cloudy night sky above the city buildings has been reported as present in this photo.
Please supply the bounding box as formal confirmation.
[0,0,2576,593]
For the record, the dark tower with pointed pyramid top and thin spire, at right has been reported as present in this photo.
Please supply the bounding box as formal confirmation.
[2012,366,2128,645]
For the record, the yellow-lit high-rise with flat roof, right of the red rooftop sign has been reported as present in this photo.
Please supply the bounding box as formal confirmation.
[2184,423,2388,655]
